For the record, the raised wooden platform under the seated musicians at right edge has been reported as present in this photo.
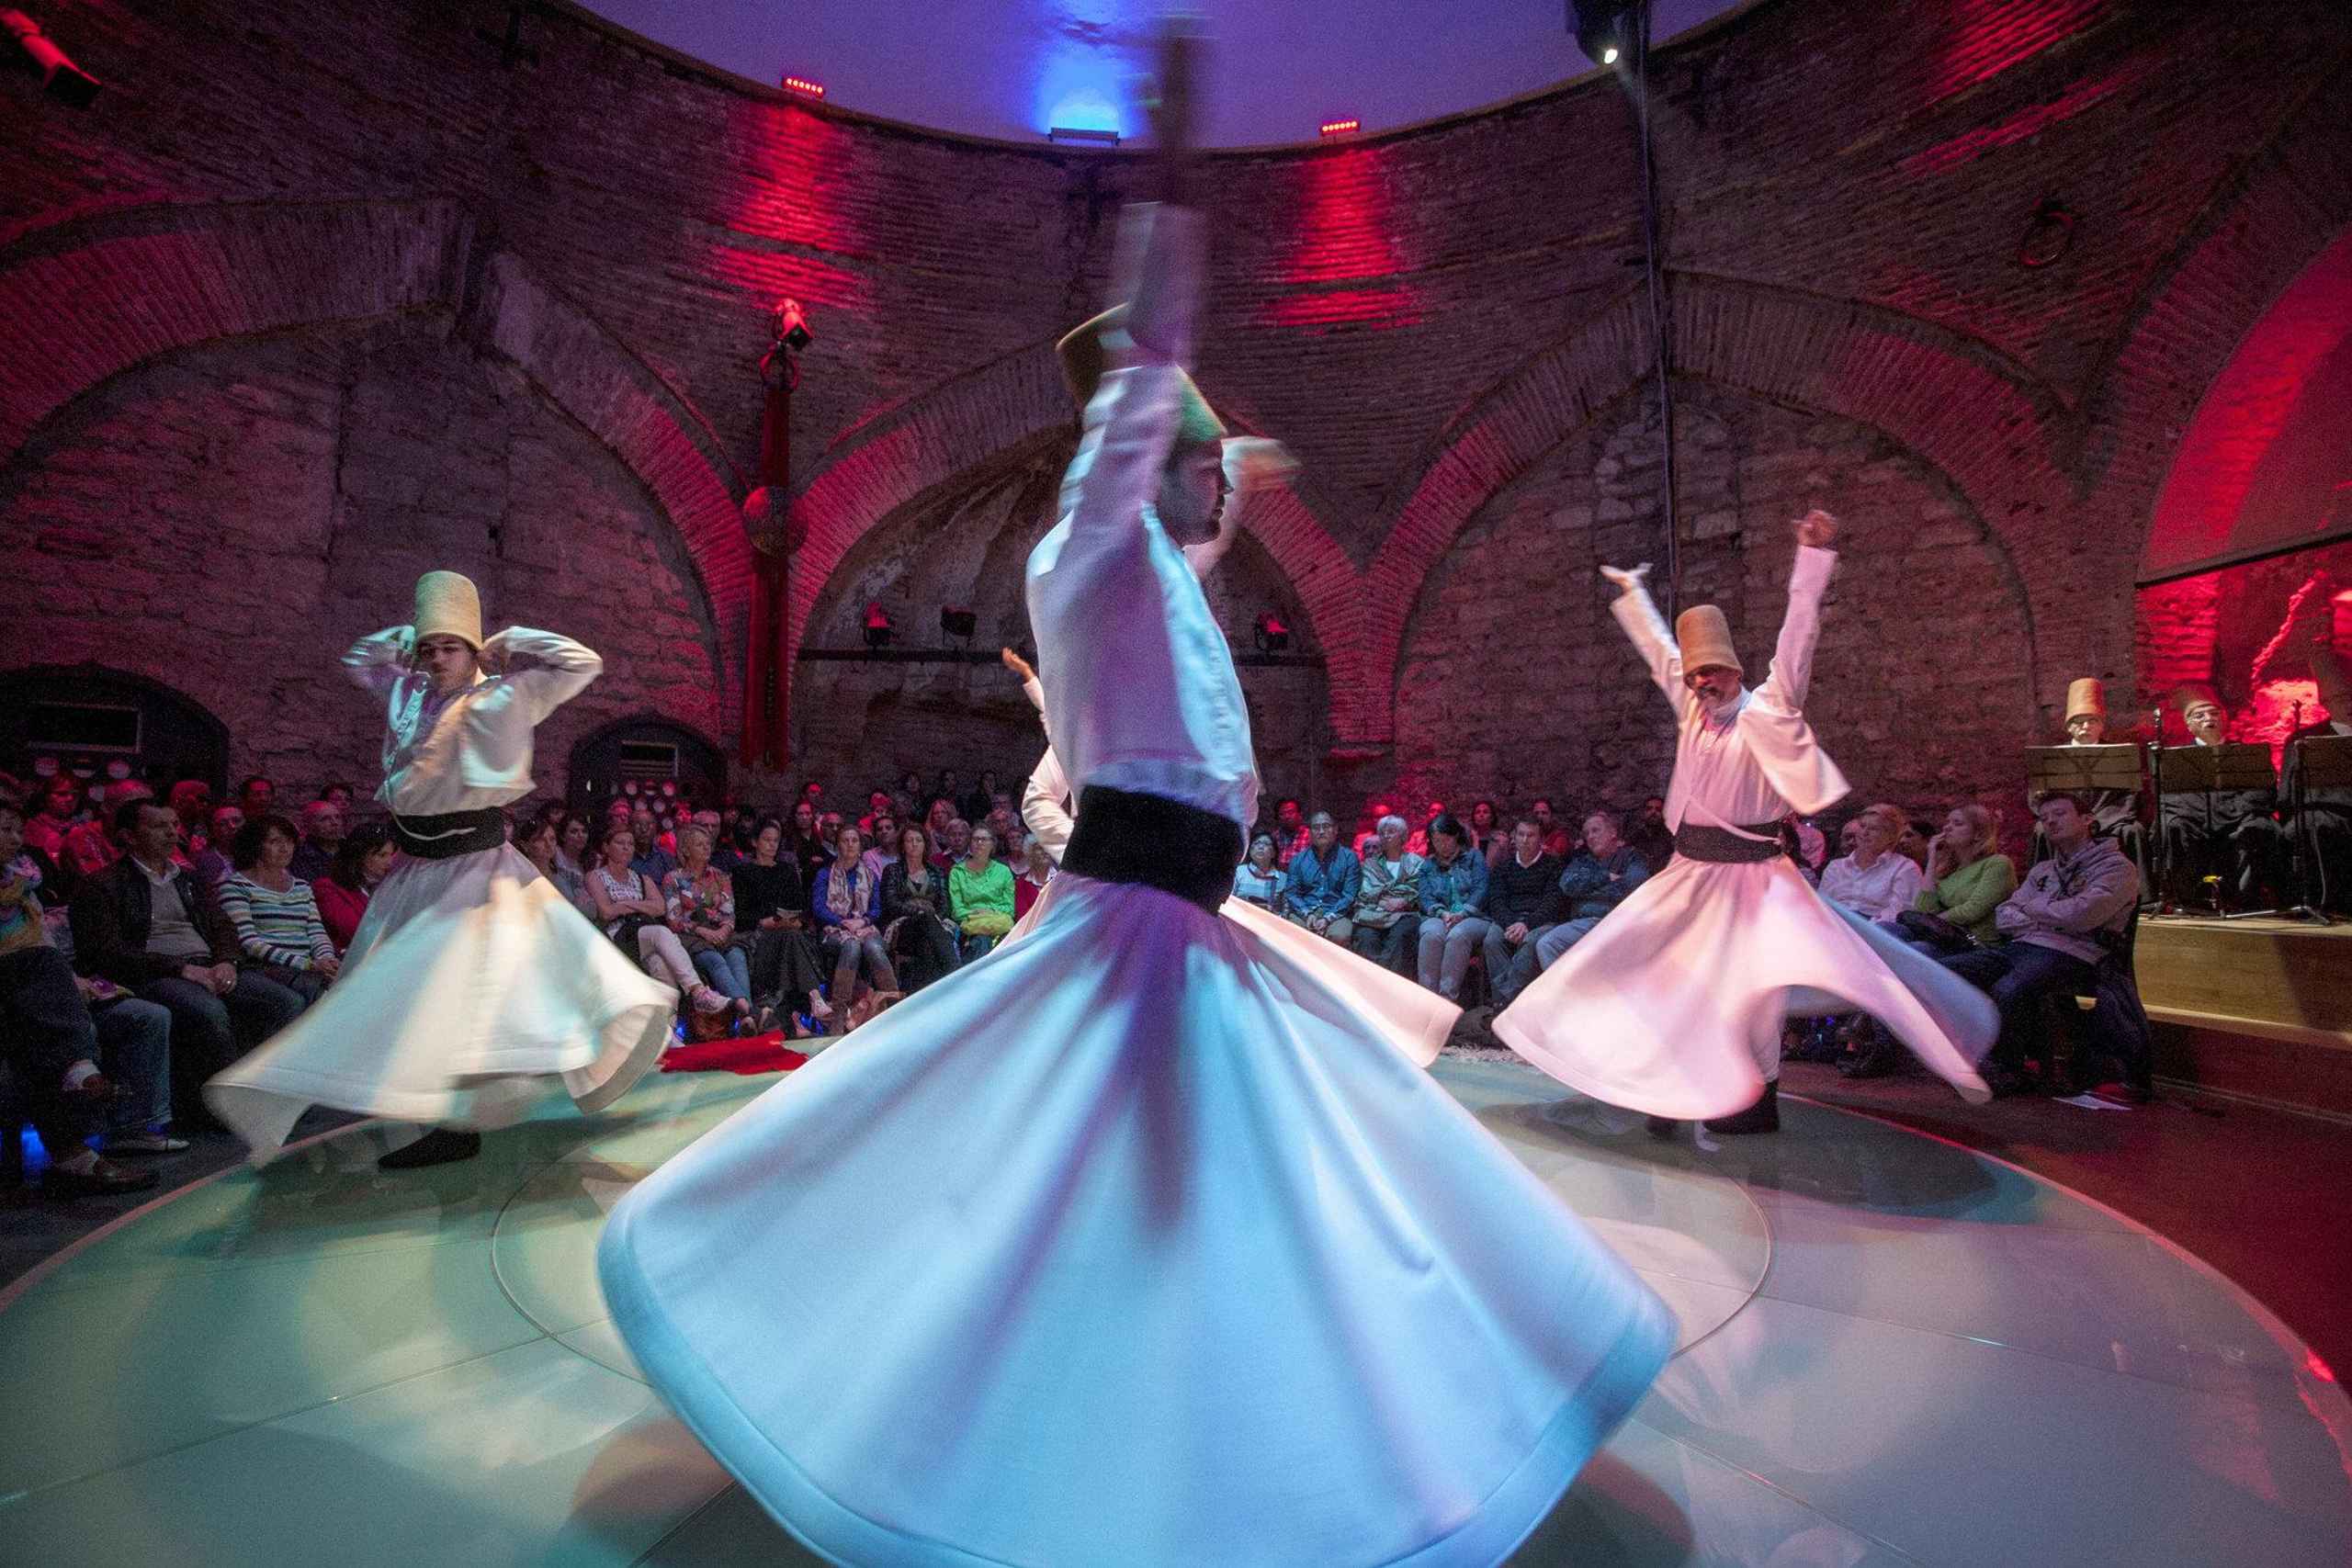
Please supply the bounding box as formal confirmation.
[2135,917,2352,1119]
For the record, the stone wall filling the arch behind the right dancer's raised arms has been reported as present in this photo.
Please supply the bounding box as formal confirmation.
[1397,388,2034,813]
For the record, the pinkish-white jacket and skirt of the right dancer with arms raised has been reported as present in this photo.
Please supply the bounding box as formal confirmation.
[1494,547,1999,1119]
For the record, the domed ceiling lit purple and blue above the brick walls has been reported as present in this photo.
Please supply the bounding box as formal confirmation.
[569,0,1738,146]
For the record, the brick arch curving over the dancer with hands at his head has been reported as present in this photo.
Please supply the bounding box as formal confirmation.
[0,202,751,722]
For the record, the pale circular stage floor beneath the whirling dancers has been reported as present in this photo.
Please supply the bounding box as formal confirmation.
[0,1058,2352,1568]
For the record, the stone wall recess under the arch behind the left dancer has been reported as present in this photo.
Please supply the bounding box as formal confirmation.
[0,315,718,799]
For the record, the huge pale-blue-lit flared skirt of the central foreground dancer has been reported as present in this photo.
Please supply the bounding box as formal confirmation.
[597,872,1672,1568]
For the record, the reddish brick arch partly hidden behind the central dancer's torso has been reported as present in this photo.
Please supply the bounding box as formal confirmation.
[778,359,1364,686]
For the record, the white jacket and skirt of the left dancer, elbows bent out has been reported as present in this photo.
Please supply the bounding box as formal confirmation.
[205,626,677,1164]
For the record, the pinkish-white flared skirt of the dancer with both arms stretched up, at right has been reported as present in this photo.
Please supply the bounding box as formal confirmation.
[1494,856,1999,1119]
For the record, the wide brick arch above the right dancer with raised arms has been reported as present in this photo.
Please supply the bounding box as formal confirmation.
[1331,275,2072,752]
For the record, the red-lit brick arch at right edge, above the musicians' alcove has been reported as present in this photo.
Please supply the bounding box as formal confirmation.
[2076,62,2352,559]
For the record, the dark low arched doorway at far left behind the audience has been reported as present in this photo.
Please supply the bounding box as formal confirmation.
[0,665,228,799]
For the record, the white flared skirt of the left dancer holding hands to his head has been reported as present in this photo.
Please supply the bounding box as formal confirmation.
[205,846,677,1161]
